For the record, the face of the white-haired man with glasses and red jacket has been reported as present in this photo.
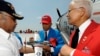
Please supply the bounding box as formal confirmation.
[67,4,83,25]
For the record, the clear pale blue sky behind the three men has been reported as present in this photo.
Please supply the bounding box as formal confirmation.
[6,0,71,31]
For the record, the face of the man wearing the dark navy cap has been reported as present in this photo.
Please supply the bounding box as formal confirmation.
[0,12,17,33]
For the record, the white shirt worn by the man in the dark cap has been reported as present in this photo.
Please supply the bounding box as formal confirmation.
[0,28,20,56]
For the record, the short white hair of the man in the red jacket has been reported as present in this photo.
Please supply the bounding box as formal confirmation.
[71,0,93,16]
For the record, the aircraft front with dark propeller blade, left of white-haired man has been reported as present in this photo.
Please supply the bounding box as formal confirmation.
[56,8,74,44]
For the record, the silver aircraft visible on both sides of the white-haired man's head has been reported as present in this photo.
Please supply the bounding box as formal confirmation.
[56,0,100,43]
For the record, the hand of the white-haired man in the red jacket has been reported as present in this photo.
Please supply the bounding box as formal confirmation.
[59,44,74,56]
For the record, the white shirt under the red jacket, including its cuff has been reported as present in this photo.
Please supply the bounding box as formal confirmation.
[70,19,91,56]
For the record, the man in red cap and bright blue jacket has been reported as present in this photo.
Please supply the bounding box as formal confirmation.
[39,15,64,56]
